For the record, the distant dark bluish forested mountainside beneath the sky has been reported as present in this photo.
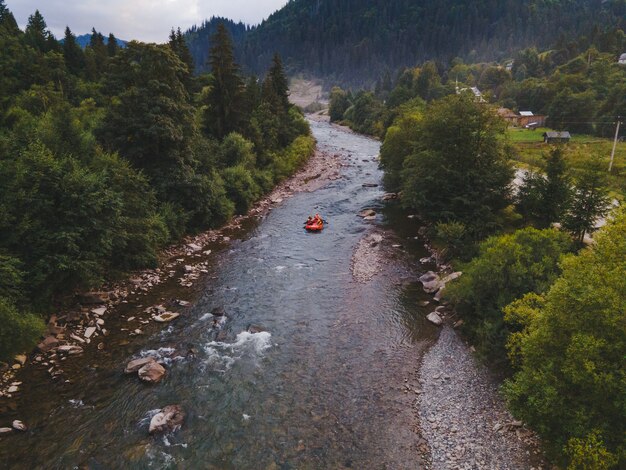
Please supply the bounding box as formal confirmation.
[187,0,626,84]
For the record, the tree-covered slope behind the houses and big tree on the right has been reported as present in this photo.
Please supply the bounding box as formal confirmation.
[330,28,626,137]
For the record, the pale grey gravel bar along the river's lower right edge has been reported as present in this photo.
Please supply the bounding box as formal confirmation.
[418,326,549,470]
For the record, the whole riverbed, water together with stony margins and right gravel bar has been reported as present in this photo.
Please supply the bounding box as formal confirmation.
[0,120,538,469]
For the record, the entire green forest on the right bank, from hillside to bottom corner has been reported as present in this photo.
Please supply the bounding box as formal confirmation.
[329,28,626,469]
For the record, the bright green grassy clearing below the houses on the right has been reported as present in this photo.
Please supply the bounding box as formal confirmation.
[507,128,626,200]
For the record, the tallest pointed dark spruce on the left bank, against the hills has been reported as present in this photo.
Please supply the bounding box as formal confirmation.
[204,24,244,140]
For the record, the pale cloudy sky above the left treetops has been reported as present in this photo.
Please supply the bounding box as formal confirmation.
[5,0,287,42]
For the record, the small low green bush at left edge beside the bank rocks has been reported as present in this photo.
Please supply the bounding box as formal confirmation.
[0,297,45,360]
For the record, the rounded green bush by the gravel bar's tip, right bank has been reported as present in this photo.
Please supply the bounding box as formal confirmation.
[446,227,570,362]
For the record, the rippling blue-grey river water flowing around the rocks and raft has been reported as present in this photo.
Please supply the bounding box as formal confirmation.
[0,122,436,469]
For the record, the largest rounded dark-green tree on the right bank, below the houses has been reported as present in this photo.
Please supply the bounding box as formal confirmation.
[401,95,513,238]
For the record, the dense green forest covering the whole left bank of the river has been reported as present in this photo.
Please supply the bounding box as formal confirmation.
[0,0,313,358]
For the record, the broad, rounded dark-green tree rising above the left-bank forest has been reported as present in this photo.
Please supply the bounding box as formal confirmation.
[97,41,196,180]
